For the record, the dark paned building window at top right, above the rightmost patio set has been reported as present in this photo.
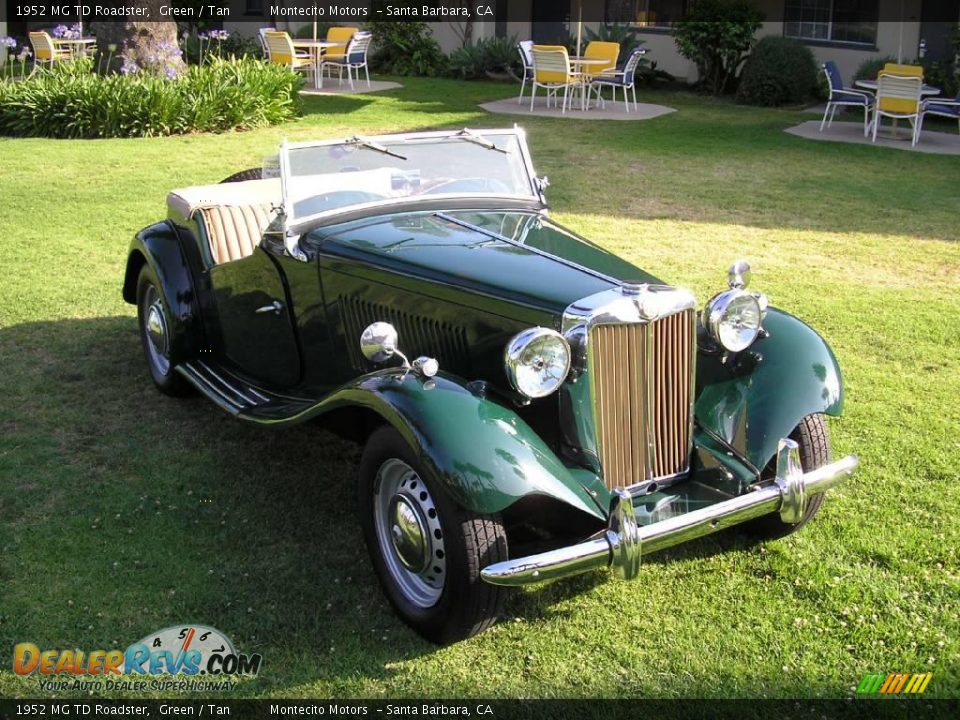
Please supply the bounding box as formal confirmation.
[783,0,877,45]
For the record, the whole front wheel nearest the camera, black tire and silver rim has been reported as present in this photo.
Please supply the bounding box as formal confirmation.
[359,427,507,644]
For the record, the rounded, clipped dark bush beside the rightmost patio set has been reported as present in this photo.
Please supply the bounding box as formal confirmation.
[737,35,817,107]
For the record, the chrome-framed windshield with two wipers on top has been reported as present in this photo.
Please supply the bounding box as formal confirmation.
[281,130,537,223]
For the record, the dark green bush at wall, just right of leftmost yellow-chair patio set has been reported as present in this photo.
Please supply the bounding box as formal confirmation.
[366,14,447,77]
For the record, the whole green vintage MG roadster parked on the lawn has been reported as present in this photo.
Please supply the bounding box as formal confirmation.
[123,128,857,642]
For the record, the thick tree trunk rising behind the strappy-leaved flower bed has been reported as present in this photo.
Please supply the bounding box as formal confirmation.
[93,0,184,76]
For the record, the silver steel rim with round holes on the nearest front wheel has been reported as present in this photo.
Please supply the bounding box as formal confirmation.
[373,458,447,608]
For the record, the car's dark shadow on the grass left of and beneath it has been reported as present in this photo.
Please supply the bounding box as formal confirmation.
[0,316,788,696]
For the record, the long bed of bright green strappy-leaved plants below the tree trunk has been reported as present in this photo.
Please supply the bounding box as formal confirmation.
[0,58,303,138]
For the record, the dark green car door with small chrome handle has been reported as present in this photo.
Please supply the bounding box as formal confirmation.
[210,246,301,389]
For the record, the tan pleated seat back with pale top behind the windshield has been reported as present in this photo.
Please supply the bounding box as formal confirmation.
[167,178,280,265]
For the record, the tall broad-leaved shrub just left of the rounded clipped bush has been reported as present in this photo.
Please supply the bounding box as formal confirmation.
[672,0,763,95]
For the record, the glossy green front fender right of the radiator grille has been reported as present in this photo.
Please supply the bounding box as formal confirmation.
[695,308,843,470]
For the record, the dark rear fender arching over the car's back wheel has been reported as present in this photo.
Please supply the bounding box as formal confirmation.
[123,220,204,365]
